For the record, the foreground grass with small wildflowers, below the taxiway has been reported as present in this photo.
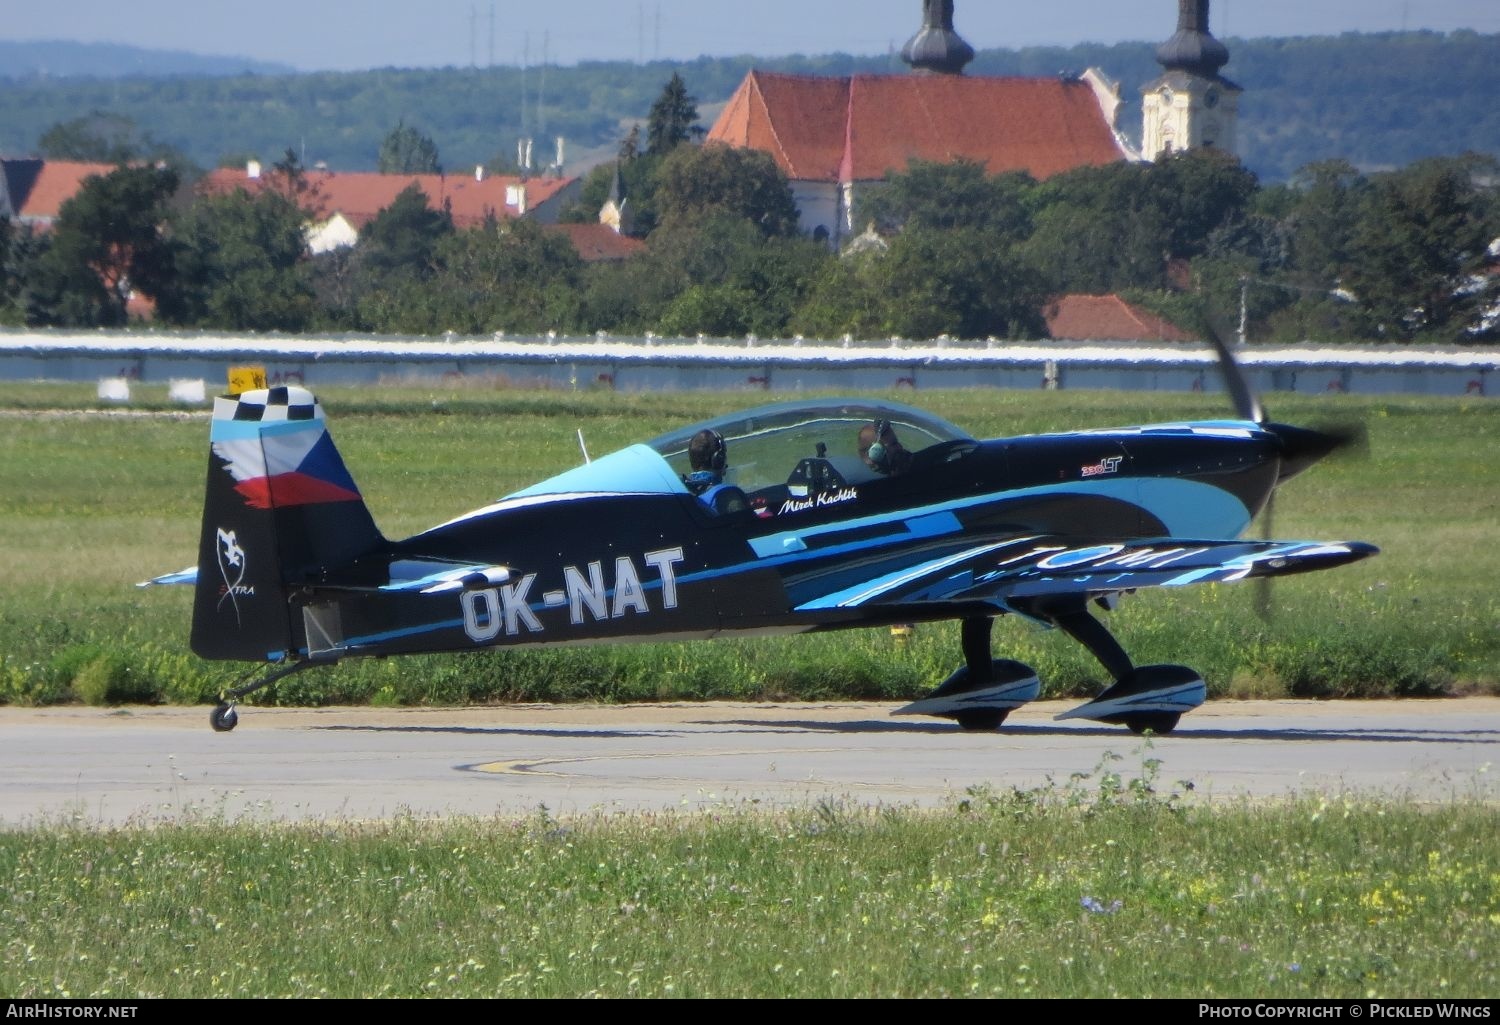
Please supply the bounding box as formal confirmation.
[0,765,1500,999]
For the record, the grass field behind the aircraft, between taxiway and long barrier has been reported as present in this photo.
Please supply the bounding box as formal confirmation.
[0,384,1500,704]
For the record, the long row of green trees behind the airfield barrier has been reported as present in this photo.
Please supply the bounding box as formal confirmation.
[0,77,1500,341]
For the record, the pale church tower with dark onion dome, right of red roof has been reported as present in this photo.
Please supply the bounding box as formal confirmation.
[1140,0,1244,161]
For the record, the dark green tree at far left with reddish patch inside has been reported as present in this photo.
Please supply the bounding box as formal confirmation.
[38,167,180,327]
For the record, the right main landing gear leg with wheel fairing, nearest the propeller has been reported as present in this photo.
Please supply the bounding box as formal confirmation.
[1046,599,1208,734]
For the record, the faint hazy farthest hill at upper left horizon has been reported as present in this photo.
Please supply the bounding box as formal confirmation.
[0,41,297,80]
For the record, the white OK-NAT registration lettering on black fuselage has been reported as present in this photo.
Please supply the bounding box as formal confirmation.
[459,548,684,644]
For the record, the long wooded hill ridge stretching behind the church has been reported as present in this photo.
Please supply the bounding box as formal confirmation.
[0,32,1500,182]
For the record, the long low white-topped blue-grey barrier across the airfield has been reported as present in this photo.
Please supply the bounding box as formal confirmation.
[0,330,1500,396]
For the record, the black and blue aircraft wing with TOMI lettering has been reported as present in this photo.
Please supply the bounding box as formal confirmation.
[798,536,1379,611]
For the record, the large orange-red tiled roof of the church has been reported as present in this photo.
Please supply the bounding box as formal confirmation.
[708,71,1125,182]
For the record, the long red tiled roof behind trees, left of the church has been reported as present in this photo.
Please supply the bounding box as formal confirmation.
[198,168,573,228]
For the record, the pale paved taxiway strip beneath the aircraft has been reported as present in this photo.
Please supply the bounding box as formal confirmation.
[0,698,1500,827]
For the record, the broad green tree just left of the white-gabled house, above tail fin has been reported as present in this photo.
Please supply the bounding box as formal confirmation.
[173,189,317,332]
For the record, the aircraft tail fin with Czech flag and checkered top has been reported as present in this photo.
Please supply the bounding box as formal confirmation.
[192,387,386,660]
